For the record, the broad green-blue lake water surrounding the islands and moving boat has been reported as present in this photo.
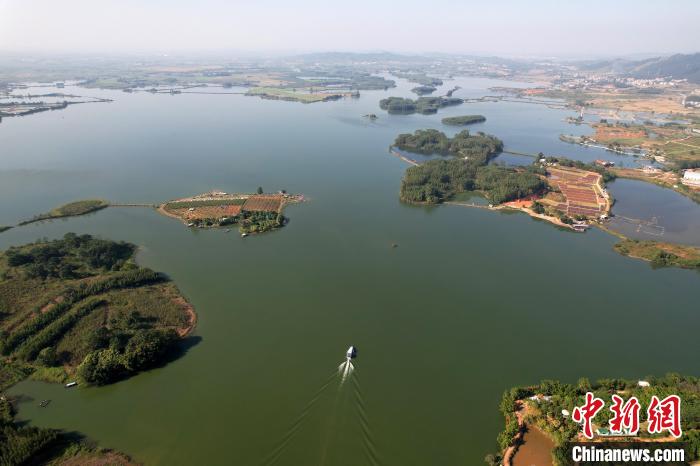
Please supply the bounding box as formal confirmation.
[0,79,700,466]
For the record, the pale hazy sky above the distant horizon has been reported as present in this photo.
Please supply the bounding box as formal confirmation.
[0,0,700,56]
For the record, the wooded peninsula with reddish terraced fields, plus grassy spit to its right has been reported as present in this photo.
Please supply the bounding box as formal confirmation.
[391,129,700,269]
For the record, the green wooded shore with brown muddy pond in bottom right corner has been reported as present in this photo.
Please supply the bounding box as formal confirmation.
[485,374,700,466]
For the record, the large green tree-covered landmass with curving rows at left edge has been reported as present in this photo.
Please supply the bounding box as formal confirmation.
[0,233,196,385]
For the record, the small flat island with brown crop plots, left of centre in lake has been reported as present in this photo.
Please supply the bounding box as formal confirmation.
[158,188,304,236]
